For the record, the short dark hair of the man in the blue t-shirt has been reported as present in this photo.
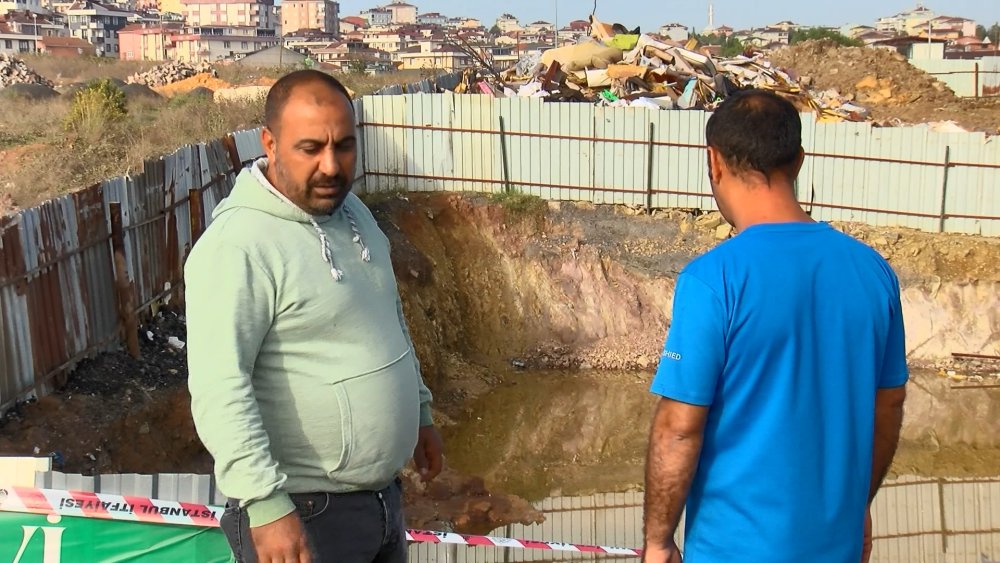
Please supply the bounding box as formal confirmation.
[705,89,802,175]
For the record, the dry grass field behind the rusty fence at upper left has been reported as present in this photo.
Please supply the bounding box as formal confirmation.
[0,56,446,214]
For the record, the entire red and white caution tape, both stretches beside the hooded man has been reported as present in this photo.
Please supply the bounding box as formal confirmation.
[0,486,642,556]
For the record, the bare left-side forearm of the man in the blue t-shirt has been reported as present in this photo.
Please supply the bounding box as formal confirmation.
[645,400,702,547]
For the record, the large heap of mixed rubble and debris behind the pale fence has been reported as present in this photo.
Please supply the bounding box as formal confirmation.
[456,16,869,121]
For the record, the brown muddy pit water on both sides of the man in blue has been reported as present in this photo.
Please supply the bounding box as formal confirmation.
[444,370,1000,500]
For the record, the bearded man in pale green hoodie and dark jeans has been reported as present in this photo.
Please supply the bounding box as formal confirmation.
[185,70,443,563]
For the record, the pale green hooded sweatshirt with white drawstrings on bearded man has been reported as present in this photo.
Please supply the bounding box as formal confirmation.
[184,159,432,526]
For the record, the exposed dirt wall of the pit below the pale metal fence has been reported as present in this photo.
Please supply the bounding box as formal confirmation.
[384,194,1000,392]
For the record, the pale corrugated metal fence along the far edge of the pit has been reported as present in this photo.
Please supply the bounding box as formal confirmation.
[360,93,1000,235]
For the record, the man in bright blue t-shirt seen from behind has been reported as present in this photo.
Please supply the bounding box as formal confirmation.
[644,90,908,563]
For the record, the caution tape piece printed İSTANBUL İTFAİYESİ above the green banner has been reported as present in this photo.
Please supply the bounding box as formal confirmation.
[0,487,223,527]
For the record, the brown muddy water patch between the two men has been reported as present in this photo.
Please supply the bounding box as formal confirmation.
[445,370,654,500]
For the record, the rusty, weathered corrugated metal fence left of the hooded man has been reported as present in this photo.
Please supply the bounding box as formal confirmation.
[0,102,361,413]
